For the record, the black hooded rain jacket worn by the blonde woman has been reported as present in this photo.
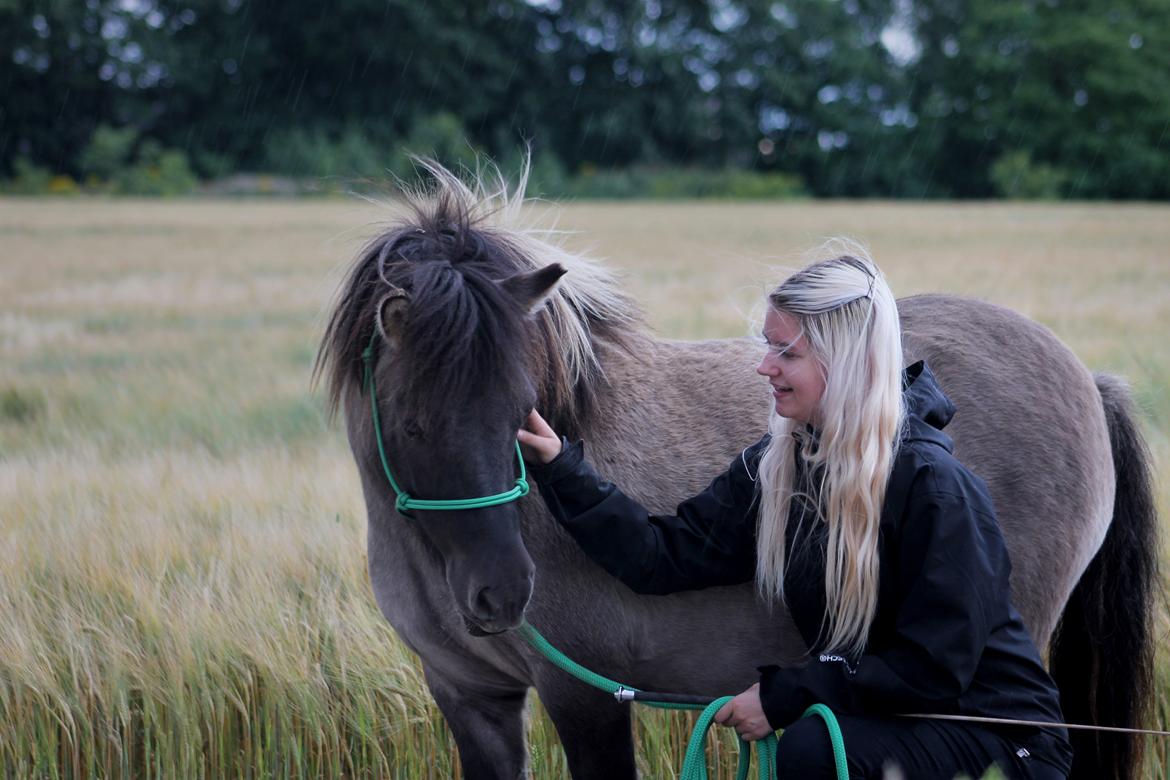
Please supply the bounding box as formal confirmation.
[532,363,1072,769]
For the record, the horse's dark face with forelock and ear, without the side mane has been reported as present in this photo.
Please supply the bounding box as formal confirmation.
[362,259,564,633]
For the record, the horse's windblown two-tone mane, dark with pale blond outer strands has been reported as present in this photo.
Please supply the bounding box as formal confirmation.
[312,159,646,433]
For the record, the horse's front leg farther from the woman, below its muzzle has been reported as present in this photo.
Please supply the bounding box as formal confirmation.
[424,664,528,780]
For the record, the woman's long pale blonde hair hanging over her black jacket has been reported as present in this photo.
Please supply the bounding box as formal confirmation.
[756,242,904,656]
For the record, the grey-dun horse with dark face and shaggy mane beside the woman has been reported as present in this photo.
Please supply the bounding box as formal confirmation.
[314,163,1157,780]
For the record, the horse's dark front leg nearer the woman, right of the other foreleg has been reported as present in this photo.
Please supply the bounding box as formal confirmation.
[536,670,638,780]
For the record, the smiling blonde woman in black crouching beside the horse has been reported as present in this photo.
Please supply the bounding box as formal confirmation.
[518,253,1072,778]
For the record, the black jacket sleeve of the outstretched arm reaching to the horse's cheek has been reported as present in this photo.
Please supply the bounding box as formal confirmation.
[532,436,769,594]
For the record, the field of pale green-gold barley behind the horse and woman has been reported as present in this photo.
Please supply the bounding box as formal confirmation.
[0,199,1170,779]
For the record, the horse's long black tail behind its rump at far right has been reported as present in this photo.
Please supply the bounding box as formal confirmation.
[1049,374,1163,780]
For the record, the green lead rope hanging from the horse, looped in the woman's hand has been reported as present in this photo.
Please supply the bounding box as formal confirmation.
[518,623,849,780]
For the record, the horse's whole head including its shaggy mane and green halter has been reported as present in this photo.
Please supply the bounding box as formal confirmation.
[316,161,629,634]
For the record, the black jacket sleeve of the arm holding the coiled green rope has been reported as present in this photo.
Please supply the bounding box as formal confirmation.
[759,477,1011,729]
